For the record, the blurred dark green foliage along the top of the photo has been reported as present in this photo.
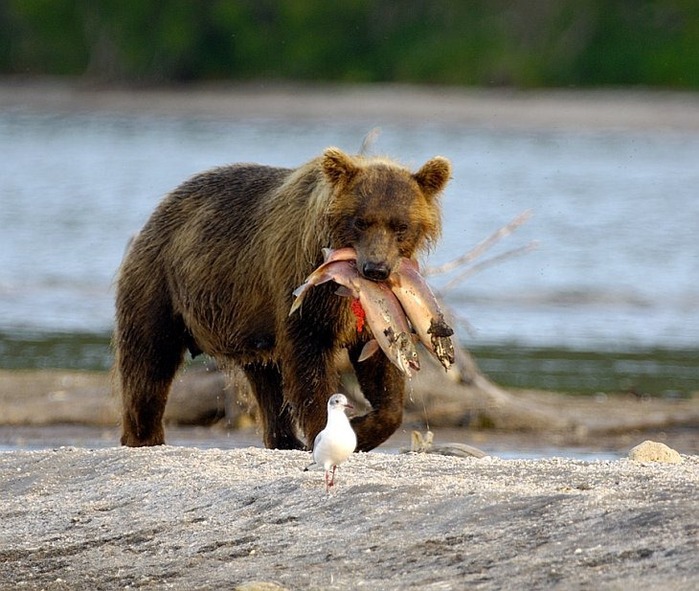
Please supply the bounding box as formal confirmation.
[0,0,699,89]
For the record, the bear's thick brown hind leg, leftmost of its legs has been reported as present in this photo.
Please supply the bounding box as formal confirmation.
[115,302,184,447]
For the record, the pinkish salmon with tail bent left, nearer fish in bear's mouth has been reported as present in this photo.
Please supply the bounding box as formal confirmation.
[289,258,420,376]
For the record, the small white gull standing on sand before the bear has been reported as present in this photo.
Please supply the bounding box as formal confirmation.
[306,394,357,492]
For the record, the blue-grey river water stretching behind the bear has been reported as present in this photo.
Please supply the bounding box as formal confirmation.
[0,109,699,391]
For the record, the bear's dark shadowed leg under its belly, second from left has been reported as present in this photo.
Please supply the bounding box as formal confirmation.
[244,363,304,449]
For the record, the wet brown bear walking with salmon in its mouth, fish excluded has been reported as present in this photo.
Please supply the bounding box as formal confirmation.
[114,148,451,451]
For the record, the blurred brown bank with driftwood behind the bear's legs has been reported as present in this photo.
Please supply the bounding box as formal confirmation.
[0,364,699,443]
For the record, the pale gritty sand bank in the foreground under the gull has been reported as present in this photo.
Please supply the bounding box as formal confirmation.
[0,447,699,591]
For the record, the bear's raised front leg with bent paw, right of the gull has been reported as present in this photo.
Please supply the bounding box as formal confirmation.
[349,343,405,451]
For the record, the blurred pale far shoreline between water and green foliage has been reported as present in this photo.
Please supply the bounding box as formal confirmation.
[0,77,699,133]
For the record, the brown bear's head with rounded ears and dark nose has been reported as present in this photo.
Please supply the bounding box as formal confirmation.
[321,148,451,281]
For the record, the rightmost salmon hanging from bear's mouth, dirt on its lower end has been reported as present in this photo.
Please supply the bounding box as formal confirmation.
[388,258,454,369]
